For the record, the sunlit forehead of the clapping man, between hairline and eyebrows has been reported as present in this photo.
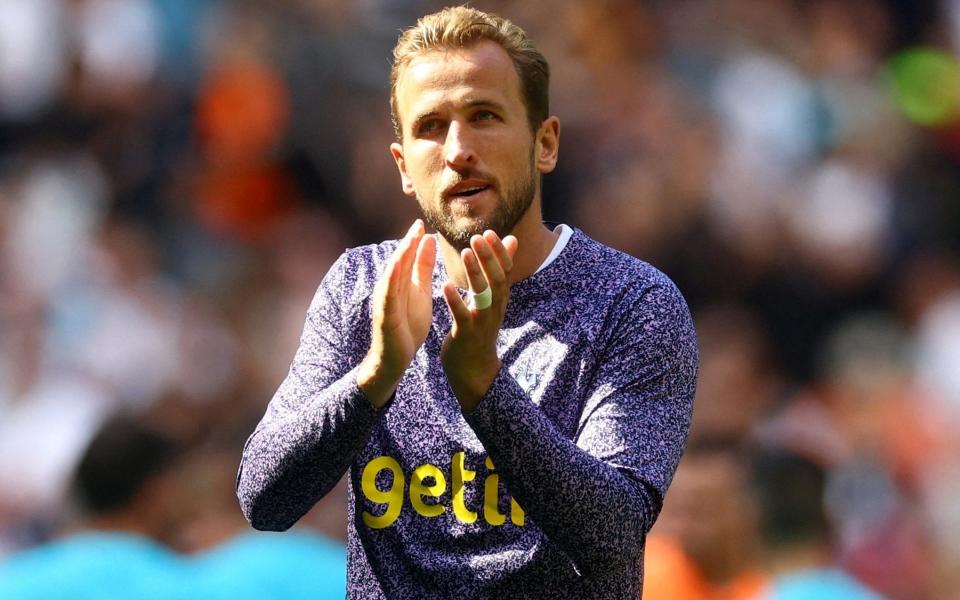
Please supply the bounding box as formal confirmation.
[397,41,523,121]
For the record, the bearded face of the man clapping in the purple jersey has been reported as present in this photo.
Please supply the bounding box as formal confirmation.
[390,41,552,249]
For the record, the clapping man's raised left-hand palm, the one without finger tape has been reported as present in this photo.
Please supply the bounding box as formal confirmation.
[357,219,437,408]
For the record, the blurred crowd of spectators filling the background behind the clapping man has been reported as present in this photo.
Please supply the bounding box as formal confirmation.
[0,0,960,600]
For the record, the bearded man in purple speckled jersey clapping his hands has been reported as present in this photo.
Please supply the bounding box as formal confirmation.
[238,7,697,599]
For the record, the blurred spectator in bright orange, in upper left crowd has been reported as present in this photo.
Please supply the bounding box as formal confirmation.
[195,3,295,240]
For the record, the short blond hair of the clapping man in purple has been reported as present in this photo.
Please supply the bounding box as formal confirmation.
[390,6,550,141]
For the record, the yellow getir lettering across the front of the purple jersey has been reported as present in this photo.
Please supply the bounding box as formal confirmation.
[360,452,523,529]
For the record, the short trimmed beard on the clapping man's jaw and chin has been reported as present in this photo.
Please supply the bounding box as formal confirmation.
[417,150,537,251]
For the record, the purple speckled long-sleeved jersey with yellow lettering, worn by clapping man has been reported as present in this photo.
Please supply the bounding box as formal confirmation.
[238,231,698,600]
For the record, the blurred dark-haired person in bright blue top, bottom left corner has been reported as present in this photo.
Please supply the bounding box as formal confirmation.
[0,419,187,600]
